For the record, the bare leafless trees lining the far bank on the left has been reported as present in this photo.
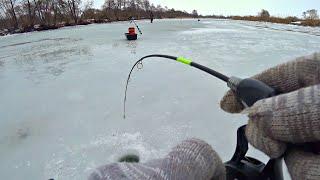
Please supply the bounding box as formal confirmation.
[0,0,194,33]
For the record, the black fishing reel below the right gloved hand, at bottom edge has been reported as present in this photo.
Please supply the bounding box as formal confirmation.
[225,126,283,180]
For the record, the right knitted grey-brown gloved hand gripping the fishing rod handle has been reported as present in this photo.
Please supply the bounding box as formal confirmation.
[220,53,320,179]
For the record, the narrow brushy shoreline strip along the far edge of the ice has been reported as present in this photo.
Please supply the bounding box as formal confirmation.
[0,16,320,36]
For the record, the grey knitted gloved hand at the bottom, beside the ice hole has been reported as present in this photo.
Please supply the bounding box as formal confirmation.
[89,139,225,180]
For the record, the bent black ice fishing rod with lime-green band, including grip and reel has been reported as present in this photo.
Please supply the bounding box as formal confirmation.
[123,54,283,180]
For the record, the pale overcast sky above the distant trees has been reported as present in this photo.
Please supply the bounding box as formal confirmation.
[94,0,320,17]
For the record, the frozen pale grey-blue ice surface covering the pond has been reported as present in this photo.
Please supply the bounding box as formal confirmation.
[0,20,320,180]
